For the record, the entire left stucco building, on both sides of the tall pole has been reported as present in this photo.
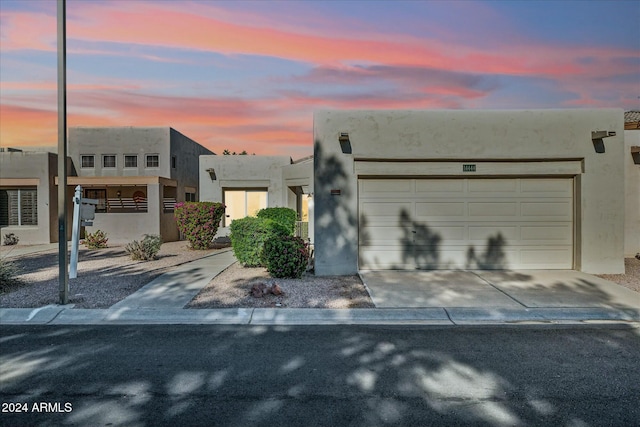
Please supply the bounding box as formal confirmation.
[0,127,213,244]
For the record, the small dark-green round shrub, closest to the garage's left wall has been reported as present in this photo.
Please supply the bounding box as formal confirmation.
[264,236,309,279]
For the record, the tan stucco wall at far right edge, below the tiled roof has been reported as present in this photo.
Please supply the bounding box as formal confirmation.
[624,129,640,258]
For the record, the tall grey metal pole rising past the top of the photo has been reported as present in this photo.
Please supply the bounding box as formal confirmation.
[58,0,69,304]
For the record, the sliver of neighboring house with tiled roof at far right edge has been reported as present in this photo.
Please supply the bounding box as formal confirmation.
[624,111,640,257]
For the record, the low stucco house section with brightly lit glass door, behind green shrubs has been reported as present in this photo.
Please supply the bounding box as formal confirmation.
[200,155,313,241]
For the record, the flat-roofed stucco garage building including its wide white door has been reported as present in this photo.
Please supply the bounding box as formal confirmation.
[313,109,624,275]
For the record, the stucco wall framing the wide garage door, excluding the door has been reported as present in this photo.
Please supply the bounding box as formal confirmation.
[314,109,625,275]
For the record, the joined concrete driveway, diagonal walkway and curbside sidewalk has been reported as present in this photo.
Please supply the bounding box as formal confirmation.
[0,250,640,327]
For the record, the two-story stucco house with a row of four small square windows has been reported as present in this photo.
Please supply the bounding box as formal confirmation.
[67,127,213,244]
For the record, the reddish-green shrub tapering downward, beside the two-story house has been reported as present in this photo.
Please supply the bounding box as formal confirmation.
[174,202,224,249]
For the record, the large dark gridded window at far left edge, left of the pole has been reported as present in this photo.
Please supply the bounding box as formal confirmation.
[0,188,38,226]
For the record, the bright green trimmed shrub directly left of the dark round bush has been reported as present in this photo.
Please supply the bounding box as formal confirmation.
[229,217,289,267]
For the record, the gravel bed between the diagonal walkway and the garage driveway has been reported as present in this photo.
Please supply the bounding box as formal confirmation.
[186,263,375,308]
